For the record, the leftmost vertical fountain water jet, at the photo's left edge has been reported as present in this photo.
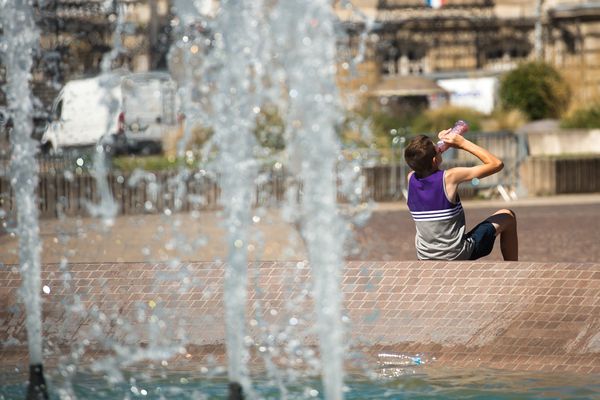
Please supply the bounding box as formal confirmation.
[0,0,42,365]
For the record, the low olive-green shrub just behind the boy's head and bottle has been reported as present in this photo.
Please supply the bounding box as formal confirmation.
[412,106,484,135]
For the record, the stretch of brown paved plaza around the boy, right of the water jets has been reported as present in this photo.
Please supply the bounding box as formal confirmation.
[350,196,600,263]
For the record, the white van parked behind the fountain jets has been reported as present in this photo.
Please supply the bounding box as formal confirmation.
[41,72,177,153]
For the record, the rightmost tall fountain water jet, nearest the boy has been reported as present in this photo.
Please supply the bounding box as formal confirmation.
[273,0,346,399]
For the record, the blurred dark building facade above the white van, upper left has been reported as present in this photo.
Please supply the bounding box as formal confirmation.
[0,0,172,108]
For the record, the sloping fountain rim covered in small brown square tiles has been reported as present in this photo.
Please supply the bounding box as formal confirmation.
[0,262,600,373]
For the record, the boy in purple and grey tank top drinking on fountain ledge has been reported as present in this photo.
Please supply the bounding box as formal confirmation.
[404,129,519,261]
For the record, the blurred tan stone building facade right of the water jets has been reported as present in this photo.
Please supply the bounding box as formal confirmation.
[338,0,600,111]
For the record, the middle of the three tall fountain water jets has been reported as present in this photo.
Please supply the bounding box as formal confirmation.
[204,0,262,392]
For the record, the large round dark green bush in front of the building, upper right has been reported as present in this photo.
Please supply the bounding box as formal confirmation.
[499,62,571,120]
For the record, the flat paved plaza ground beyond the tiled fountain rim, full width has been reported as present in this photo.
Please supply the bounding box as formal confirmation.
[0,194,600,264]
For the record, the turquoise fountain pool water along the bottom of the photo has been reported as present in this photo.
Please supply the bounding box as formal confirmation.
[0,368,600,400]
